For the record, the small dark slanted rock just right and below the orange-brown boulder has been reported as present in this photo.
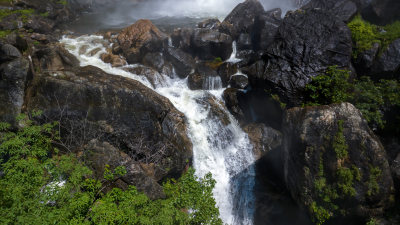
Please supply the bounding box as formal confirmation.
[165,47,196,78]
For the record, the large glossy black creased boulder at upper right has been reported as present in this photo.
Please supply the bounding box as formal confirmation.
[242,9,352,105]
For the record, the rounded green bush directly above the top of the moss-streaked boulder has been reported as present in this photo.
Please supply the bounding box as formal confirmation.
[305,66,351,105]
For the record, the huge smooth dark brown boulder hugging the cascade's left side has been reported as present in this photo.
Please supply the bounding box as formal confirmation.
[25,66,192,181]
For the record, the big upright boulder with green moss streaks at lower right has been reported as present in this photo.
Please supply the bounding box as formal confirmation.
[283,103,394,221]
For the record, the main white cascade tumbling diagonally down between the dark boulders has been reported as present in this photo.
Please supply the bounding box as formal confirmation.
[60,36,255,225]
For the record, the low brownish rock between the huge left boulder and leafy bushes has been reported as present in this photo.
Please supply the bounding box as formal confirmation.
[83,139,165,199]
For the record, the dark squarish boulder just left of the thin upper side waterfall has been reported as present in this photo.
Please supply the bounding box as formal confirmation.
[191,28,232,60]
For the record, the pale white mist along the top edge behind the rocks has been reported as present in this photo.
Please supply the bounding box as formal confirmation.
[72,0,304,33]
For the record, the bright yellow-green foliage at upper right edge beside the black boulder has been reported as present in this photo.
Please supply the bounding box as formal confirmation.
[348,15,400,58]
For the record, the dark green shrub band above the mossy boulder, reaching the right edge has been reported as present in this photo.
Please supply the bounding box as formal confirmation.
[305,67,400,129]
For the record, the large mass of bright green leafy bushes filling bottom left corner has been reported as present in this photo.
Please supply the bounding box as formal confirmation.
[0,118,222,225]
